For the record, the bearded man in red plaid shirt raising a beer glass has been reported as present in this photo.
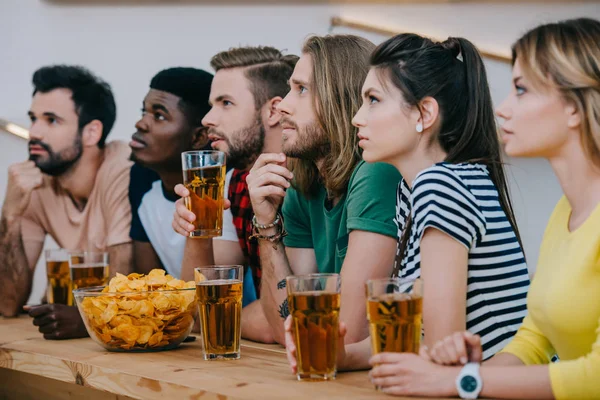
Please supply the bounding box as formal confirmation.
[173,47,298,343]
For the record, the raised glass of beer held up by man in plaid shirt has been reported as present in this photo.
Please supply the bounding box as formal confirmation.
[181,151,226,238]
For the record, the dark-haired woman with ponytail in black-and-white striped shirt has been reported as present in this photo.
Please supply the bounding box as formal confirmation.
[288,34,529,369]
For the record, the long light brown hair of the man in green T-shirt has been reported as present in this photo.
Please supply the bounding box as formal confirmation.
[291,35,375,198]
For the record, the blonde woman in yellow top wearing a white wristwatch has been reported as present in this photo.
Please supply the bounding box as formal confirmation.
[371,18,600,399]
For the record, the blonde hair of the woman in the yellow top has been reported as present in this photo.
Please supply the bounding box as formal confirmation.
[512,18,600,167]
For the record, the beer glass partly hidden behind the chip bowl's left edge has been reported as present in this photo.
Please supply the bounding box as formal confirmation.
[69,251,109,290]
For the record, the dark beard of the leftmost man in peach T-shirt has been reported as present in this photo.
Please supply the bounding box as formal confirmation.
[29,132,83,176]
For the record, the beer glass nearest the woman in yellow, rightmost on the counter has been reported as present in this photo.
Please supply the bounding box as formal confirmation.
[366,278,423,354]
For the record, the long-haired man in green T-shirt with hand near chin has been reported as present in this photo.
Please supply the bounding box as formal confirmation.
[247,35,400,343]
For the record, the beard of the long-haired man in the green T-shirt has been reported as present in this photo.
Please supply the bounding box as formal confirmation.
[282,119,331,161]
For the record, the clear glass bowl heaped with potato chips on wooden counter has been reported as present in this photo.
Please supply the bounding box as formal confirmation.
[73,269,197,352]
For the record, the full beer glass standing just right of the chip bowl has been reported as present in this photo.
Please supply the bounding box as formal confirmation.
[194,265,244,360]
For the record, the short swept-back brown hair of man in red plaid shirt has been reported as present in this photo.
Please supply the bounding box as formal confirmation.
[210,46,298,109]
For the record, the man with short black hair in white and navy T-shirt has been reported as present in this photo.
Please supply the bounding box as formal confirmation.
[129,67,237,279]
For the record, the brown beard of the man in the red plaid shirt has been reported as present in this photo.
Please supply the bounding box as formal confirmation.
[208,114,265,169]
